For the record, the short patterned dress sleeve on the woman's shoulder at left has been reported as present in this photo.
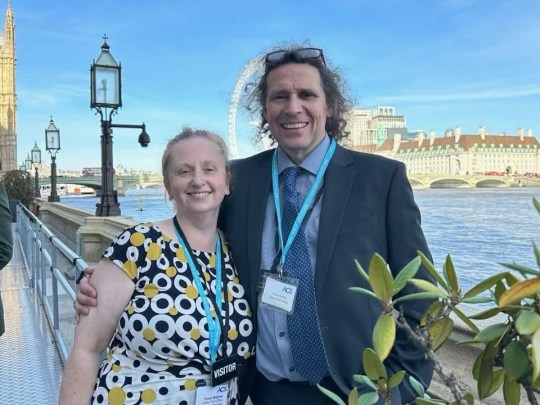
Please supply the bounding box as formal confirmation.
[102,224,156,282]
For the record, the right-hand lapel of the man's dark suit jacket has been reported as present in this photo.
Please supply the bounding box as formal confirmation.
[315,146,356,297]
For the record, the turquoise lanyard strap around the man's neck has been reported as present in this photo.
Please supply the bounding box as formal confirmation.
[272,138,336,275]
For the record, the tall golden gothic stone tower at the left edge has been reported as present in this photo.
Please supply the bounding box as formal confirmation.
[0,0,18,175]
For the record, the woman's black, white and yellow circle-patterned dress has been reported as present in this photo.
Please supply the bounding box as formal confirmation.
[92,223,255,405]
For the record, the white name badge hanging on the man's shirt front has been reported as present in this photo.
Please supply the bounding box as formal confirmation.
[259,273,298,314]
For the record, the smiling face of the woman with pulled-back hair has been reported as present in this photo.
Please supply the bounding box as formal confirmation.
[165,137,230,219]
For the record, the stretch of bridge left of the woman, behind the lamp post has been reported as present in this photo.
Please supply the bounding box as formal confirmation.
[39,174,163,195]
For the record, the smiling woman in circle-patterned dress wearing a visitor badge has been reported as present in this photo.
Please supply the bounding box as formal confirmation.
[59,128,254,405]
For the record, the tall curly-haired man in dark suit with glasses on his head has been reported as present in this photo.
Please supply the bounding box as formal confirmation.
[78,47,432,405]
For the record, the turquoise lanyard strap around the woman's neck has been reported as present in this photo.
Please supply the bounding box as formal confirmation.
[173,216,228,363]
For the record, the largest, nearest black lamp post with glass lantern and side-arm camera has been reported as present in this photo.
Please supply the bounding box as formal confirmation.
[90,35,150,217]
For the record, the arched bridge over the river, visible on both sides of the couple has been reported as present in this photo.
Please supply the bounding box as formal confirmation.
[39,174,540,195]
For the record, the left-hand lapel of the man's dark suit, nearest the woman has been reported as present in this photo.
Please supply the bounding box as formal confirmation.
[246,152,272,306]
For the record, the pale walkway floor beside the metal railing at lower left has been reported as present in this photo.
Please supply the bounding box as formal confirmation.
[0,224,63,405]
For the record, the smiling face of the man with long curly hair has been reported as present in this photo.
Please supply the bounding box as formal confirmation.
[263,63,332,164]
